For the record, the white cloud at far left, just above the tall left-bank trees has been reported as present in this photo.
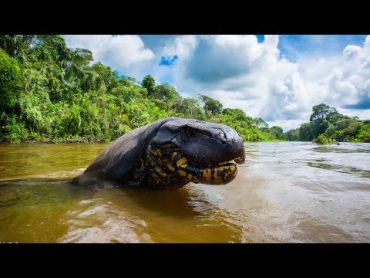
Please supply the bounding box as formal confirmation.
[65,35,155,75]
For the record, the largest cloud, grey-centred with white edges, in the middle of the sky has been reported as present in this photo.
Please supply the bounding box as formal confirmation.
[158,35,308,127]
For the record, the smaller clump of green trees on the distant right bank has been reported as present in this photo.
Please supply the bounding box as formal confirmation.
[286,103,370,144]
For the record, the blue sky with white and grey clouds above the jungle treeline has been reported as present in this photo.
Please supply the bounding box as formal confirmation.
[64,34,370,131]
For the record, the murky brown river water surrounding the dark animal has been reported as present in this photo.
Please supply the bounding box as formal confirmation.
[0,142,370,242]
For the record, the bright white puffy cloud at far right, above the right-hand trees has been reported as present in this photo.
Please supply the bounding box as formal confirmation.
[299,36,370,114]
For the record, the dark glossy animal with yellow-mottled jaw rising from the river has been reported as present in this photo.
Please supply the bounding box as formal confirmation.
[73,118,245,188]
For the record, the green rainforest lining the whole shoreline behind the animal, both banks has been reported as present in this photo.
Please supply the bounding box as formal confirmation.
[0,35,370,144]
